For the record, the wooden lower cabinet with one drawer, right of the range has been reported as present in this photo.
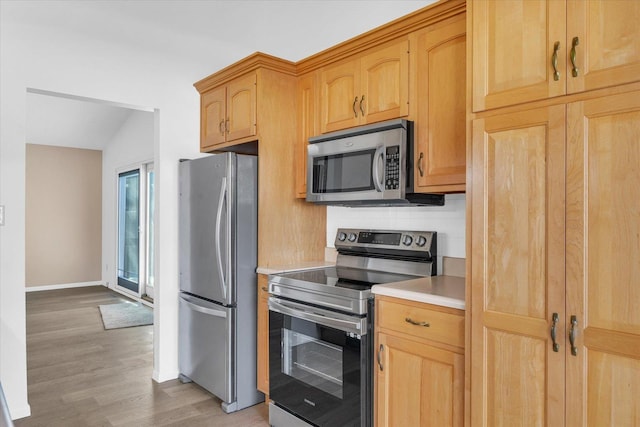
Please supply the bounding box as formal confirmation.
[374,296,464,427]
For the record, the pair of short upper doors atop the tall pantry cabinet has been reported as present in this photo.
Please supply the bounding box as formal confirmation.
[468,0,640,111]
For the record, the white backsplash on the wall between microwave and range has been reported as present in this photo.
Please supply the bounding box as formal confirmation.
[327,194,466,274]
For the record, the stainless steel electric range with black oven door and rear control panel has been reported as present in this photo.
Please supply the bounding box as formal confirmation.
[269,229,437,427]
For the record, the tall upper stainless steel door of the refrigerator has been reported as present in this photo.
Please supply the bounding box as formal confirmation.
[179,153,236,305]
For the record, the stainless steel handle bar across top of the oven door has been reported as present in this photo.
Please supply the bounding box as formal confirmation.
[269,297,367,335]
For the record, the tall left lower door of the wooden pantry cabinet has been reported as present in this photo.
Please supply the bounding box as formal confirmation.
[471,105,565,426]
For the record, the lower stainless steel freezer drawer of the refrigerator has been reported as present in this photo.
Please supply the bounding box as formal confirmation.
[178,293,236,403]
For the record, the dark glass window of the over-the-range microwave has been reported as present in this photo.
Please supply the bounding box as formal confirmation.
[313,150,376,193]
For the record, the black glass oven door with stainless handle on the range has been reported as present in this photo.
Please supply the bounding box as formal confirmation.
[269,297,373,426]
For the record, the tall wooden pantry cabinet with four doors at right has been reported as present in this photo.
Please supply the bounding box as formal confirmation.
[467,0,640,426]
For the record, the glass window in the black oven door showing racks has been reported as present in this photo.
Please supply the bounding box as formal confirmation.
[282,329,343,399]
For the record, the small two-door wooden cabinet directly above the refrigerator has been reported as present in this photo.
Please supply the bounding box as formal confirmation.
[200,72,257,151]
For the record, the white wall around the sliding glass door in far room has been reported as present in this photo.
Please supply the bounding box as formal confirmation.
[101,111,155,294]
